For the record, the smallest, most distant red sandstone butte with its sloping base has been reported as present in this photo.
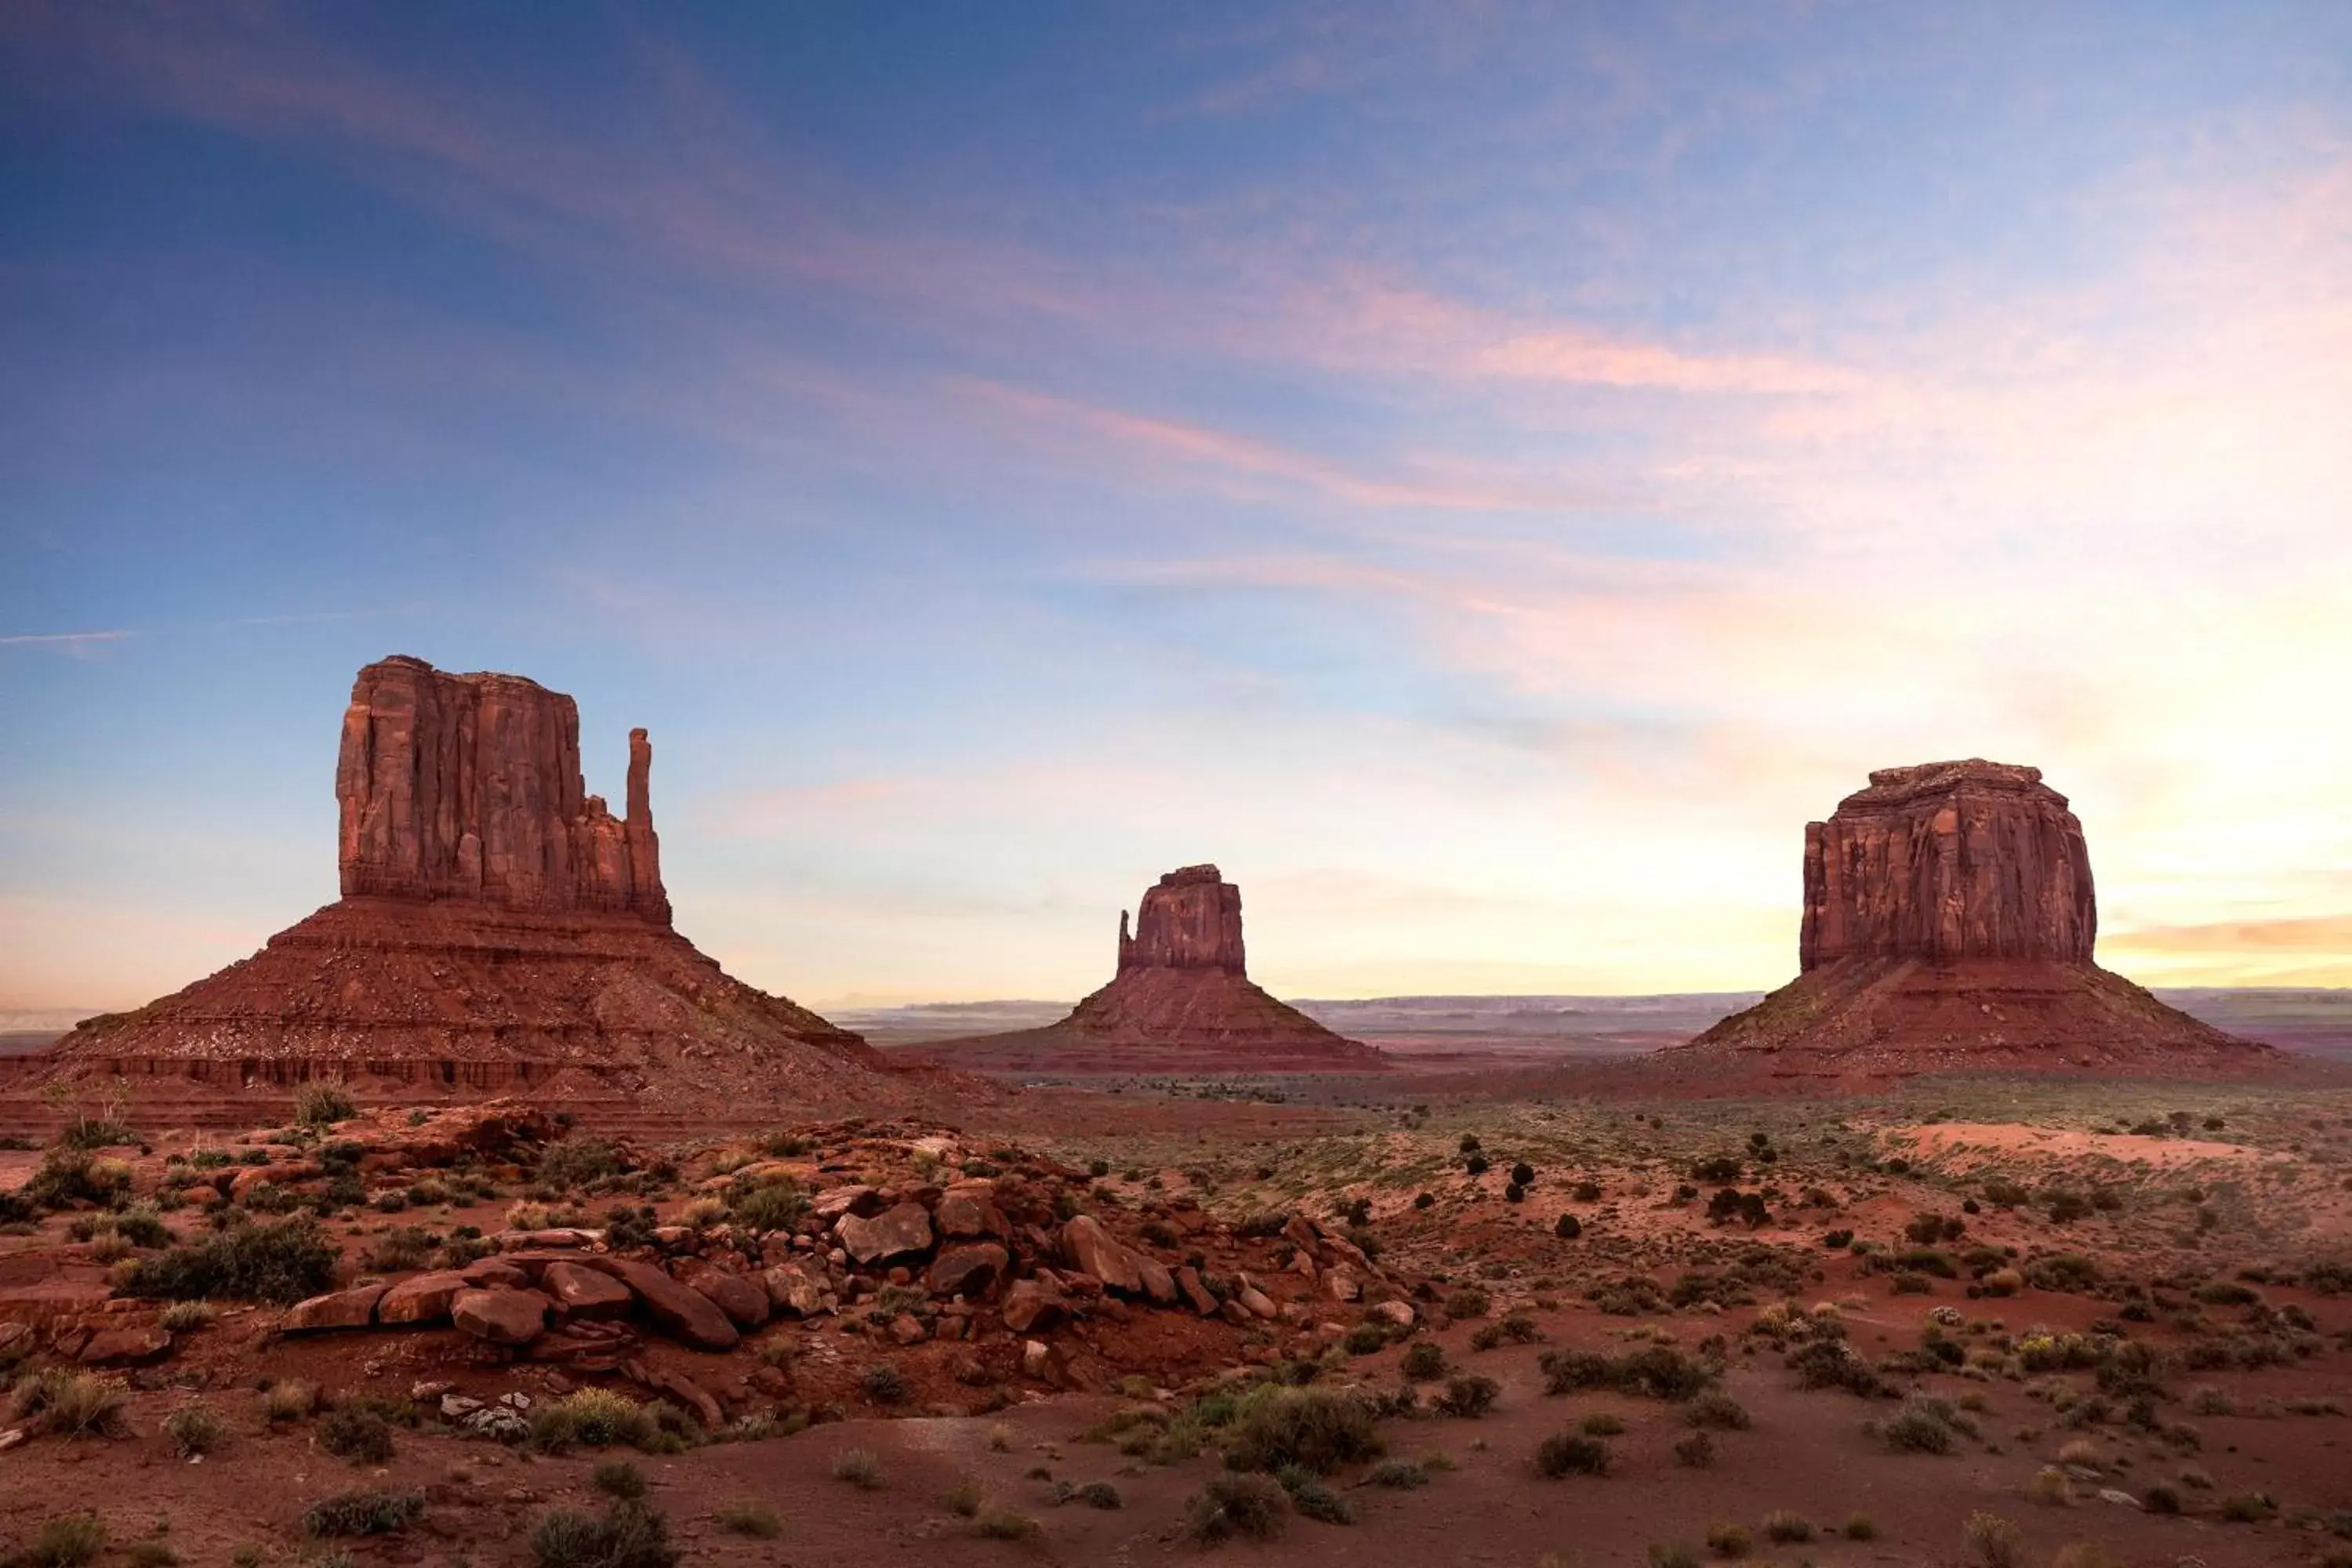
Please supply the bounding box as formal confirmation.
[924,865,1388,1072]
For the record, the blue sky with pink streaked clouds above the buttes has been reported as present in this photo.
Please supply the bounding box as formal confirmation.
[0,0,2352,1011]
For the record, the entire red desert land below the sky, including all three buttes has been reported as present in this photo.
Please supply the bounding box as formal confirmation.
[0,659,2352,1568]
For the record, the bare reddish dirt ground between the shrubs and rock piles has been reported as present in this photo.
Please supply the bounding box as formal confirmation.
[0,1079,2352,1568]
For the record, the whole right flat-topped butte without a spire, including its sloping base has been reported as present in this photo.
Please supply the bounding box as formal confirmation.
[1672,760,2270,1074]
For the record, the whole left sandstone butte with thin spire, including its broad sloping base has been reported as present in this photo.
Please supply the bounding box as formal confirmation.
[26,656,882,1114]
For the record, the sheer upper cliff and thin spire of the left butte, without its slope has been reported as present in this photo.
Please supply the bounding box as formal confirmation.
[334,656,670,926]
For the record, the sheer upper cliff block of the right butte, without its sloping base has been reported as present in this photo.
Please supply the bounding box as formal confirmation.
[1797,760,2098,973]
